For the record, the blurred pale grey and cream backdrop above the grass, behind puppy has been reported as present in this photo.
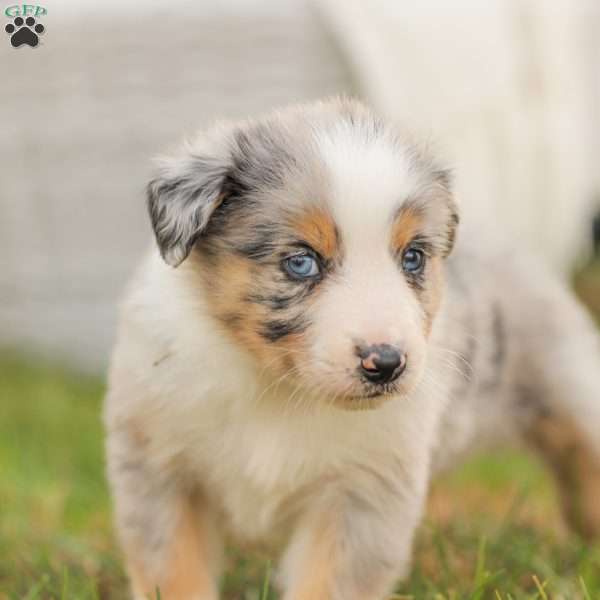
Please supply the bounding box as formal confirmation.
[0,0,600,372]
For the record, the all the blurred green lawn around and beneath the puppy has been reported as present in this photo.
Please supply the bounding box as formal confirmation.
[0,258,600,600]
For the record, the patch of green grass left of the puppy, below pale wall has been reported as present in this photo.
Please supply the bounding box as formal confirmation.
[0,355,124,600]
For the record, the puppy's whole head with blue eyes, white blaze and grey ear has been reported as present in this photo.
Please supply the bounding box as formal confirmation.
[149,102,457,408]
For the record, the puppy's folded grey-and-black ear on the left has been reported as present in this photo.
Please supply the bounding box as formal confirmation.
[147,154,229,267]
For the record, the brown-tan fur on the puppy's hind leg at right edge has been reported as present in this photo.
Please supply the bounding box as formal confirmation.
[528,415,600,539]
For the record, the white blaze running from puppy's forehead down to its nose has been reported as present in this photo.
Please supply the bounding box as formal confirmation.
[314,124,421,354]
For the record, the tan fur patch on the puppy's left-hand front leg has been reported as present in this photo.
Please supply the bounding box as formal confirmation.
[129,502,217,600]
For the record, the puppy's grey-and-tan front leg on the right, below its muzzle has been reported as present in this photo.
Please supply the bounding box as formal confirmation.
[282,478,423,600]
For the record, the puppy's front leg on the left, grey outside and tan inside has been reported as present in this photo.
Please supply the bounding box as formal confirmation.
[108,433,221,600]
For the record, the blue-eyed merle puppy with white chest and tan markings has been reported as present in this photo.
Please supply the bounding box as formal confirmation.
[105,100,600,600]
